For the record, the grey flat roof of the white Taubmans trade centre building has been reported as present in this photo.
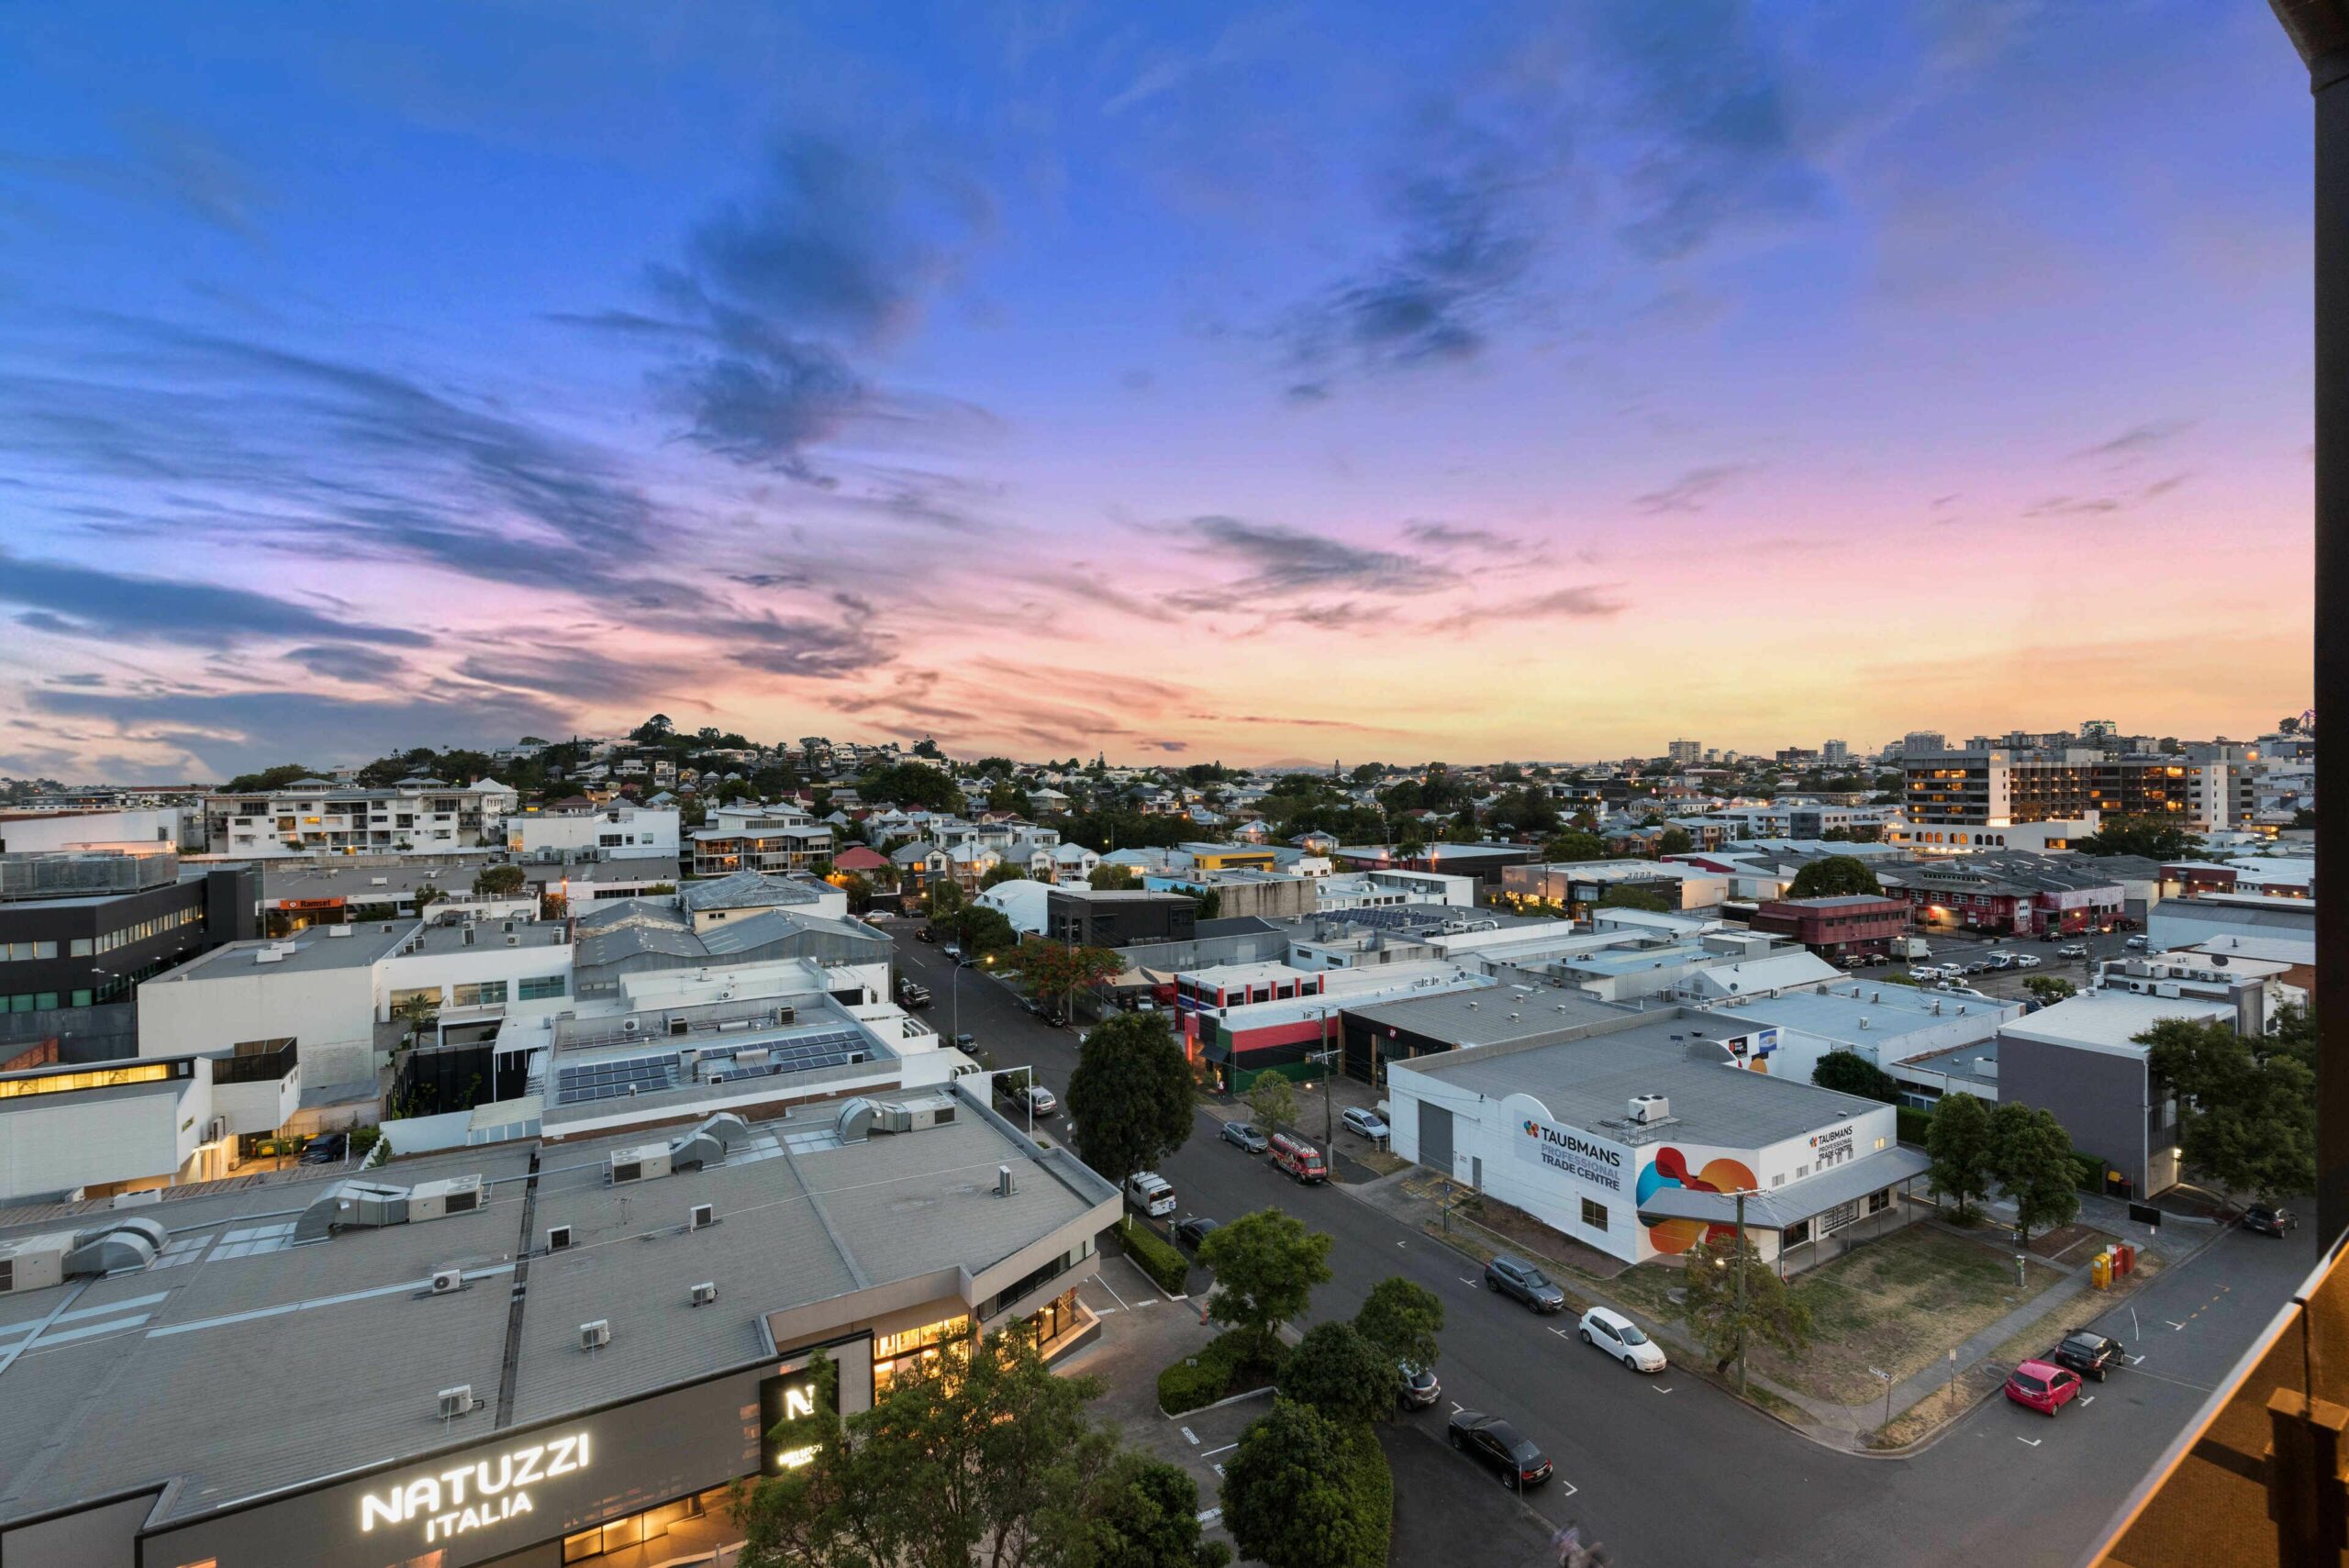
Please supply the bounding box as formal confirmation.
[1391,1009,1879,1148]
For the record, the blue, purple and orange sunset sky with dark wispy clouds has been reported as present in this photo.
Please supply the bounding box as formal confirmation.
[0,0,2311,782]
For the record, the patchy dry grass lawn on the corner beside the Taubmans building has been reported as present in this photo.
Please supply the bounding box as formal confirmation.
[1756,1225,2063,1406]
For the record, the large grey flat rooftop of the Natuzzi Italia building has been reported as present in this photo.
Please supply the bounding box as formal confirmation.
[0,1096,1116,1521]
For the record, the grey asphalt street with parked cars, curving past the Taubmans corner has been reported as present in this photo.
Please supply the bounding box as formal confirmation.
[893,922,2316,1568]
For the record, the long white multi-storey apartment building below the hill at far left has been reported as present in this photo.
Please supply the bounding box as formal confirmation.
[205,779,517,859]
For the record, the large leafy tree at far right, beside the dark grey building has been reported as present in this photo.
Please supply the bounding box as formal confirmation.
[2138,1007,2316,1202]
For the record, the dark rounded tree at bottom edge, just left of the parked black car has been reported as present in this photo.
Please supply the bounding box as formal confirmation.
[1224,1399,1384,1568]
